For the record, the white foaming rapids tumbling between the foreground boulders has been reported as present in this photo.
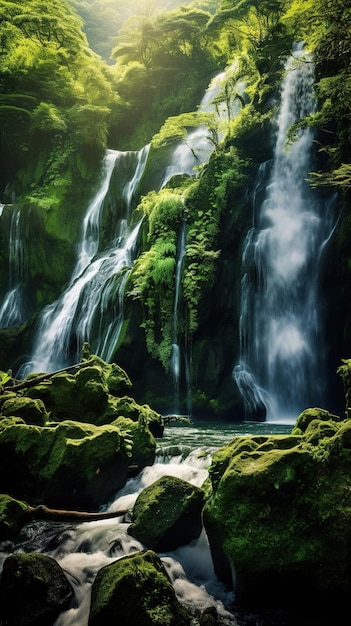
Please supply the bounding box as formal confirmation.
[0,449,236,626]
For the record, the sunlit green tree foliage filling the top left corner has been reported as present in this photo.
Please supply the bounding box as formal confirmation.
[0,0,118,200]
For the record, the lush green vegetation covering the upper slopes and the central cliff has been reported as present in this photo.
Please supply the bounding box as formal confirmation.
[0,0,351,400]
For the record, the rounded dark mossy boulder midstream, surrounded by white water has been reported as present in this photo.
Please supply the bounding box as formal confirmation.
[128,476,204,552]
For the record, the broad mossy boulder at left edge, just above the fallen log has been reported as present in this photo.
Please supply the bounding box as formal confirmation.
[0,414,128,510]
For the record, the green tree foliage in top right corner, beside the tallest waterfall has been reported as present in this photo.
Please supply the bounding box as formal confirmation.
[285,0,351,192]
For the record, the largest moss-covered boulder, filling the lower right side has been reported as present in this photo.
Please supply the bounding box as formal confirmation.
[203,410,351,611]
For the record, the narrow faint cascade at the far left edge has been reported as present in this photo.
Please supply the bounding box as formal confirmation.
[0,205,27,328]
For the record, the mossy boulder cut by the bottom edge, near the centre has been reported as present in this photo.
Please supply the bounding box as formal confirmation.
[89,550,190,626]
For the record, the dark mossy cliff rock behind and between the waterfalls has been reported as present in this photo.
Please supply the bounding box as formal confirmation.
[0,108,350,420]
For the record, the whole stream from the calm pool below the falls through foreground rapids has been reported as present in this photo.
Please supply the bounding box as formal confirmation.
[0,422,289,626]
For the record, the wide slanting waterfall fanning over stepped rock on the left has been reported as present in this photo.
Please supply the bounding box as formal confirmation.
[21,146,149,375]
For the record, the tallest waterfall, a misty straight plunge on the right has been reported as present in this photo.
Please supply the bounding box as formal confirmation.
[233,51,332,421]
